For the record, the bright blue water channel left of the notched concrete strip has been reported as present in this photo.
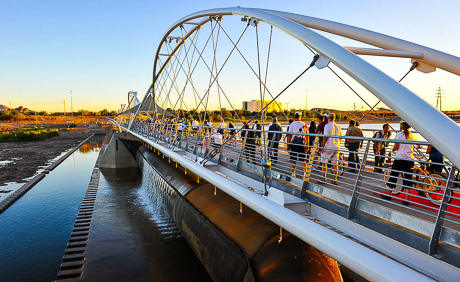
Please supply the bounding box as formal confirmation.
[0,136,103,281]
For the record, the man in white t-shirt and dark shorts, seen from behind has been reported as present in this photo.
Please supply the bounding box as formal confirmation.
[287,112,308,177]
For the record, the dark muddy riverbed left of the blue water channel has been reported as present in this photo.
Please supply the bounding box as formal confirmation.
[0,132,90,187]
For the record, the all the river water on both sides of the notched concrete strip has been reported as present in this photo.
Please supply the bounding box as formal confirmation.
[0,137,210,282]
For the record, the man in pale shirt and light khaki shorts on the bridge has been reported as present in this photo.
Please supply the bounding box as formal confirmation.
[320,113,342,184]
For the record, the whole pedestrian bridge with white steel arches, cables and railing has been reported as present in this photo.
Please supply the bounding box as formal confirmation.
[113,8,460,281]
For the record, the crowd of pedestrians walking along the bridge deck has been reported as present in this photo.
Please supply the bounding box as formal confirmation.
[151,112,444,198]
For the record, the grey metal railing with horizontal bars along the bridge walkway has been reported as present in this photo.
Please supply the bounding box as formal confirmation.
[124,121,460,254]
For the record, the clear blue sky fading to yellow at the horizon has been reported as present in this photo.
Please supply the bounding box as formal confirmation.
[0,0,460,112]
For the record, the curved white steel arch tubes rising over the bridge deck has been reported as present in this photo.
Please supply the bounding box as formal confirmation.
[151,7,460,167]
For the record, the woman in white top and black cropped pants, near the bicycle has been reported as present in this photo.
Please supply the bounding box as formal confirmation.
[380,121,421,205]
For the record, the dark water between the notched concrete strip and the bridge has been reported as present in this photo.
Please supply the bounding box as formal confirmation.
[88,159,210,281]
